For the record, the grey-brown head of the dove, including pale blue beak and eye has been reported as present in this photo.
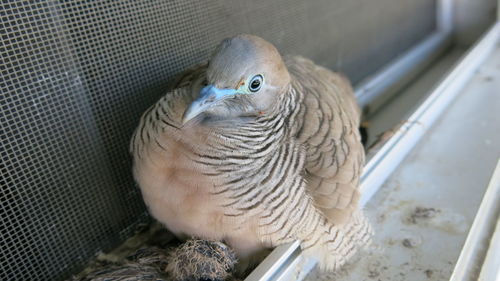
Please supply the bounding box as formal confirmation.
[183,35,290,123]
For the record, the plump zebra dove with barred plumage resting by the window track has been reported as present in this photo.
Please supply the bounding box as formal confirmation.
[130,34,372,271]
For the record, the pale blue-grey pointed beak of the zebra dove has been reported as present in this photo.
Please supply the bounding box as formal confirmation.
[182,85,238,124]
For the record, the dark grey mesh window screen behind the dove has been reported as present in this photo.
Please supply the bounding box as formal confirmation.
[0,0,436,280]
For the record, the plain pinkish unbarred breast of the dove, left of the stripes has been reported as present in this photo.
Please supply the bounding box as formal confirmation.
[134,133,228,236]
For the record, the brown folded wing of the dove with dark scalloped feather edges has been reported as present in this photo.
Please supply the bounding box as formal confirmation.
[287,57,364,223]
